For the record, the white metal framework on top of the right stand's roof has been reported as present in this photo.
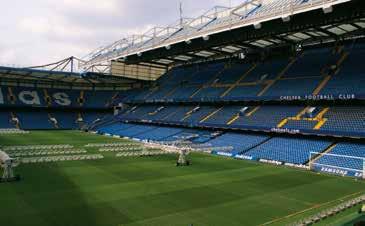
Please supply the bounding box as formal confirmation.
[81,0,351,67]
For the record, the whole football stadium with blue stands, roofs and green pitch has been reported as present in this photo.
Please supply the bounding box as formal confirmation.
[0,0,365,226]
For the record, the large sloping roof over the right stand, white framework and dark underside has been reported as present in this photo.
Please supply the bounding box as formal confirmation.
[81,0,365,73]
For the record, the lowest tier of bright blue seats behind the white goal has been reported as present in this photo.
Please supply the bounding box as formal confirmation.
[95,122,365,175]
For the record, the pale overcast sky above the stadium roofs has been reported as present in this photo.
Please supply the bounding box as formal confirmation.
[0,0,243,66]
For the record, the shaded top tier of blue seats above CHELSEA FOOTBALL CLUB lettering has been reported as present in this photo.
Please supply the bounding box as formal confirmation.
[118,45,365,102]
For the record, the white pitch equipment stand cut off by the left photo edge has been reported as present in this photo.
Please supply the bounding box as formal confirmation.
[0,151,20,182]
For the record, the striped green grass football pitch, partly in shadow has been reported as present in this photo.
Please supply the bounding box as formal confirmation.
[0,131,365,226]
